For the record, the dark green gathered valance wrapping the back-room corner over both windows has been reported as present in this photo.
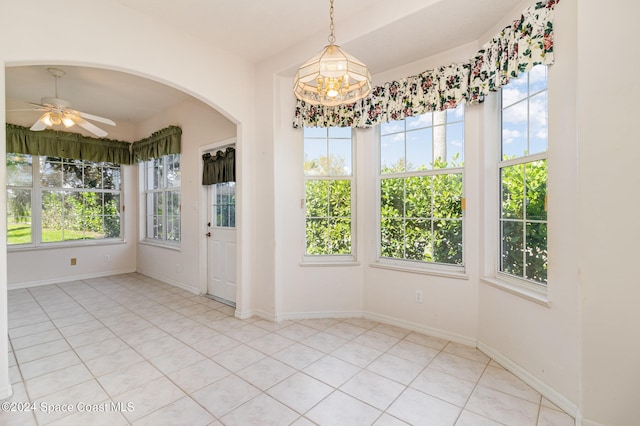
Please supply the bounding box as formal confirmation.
[6,124,182,164]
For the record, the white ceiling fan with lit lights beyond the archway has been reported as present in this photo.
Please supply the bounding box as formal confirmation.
[15,68,116,137]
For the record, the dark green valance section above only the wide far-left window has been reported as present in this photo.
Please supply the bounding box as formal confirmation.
[6,124,131,164]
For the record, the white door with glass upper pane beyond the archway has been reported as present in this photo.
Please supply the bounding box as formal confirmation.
[207,182,236,306]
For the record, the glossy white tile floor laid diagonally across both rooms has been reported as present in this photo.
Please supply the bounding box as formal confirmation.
[0,274,574,426]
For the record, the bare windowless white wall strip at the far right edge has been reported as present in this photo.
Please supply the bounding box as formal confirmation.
[576,0,640,425]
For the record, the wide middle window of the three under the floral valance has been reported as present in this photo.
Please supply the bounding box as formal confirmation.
[379,106,464,266]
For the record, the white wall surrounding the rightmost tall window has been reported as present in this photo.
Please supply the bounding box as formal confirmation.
[478,0,580,415]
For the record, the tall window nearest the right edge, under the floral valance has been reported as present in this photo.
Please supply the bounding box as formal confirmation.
[498,65,548,285]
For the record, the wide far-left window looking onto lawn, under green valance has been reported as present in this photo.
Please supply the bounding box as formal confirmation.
[7,153,121,246]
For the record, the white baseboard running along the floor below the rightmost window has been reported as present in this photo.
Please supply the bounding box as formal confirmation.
[478,341,584,420]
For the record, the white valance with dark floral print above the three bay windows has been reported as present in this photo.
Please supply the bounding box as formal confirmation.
[293,0,559,128]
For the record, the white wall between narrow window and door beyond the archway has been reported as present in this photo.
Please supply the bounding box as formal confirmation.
[132,100,236,293]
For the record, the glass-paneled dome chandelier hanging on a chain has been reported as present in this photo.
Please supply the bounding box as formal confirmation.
[293,0,371,106]
